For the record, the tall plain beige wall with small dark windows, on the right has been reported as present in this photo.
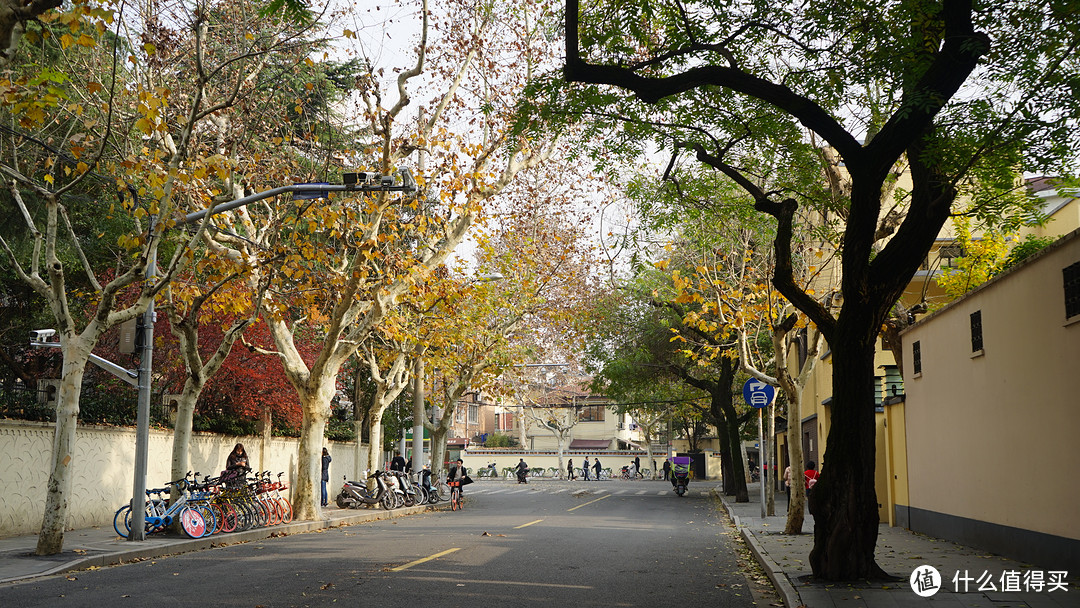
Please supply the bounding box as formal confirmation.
[904,232,1080,539]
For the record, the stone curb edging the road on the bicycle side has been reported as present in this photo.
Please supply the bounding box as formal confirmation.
[0,504,438,584]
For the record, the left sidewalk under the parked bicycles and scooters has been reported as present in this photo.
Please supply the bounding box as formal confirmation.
[0,502,429,584]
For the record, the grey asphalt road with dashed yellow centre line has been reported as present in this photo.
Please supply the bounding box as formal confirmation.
[0,481,779,608]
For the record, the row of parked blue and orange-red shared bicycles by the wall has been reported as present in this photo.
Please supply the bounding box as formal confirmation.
[112,468,293,538]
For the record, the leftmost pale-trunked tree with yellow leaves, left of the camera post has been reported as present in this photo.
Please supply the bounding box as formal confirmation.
[0,0,317,554]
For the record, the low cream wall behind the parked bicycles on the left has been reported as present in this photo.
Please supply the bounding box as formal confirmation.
[0,420,355,537]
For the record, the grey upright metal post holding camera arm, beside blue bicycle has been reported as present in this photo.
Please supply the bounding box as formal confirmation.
[127,228,158,540]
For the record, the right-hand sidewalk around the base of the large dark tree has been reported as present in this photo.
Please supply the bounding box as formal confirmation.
[716,483,1080,608]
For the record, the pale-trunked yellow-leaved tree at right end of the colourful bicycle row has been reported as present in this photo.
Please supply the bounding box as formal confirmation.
[204,0,574,518]
